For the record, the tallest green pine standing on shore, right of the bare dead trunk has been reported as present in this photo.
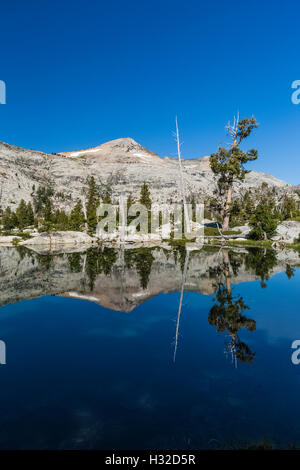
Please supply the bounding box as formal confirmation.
[210,117,258,231]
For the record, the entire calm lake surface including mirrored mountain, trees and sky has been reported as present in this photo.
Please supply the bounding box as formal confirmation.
[0,247,300,449]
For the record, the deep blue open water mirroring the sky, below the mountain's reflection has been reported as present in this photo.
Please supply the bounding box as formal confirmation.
[0,260,300,449]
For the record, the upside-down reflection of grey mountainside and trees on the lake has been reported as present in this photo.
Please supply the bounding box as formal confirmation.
[0,244,298,366]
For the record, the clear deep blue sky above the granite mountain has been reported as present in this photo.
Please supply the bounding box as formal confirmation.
[0,0,300,184]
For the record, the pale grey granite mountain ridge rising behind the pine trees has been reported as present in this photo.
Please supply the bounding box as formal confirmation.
[0,138,294,211]
